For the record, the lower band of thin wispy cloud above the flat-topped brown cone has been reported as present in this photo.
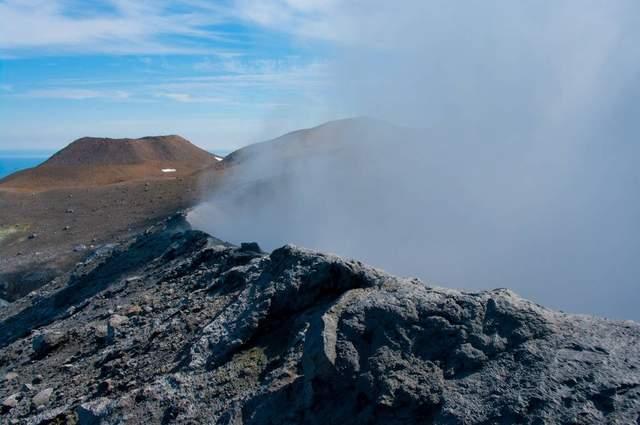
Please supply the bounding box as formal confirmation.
[16,58,329,107]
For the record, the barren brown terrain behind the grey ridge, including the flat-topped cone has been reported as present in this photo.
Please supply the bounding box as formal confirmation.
[0,136,220,301]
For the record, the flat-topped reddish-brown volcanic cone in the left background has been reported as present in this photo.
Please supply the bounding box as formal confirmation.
[0,136,217,191]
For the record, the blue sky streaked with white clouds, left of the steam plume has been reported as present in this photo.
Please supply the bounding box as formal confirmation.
[0,0,340,152]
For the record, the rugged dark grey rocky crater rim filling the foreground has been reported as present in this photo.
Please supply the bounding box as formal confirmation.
[0,217,640,425]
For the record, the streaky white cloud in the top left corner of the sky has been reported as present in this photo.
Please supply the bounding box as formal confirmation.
[0,0,239,56]
